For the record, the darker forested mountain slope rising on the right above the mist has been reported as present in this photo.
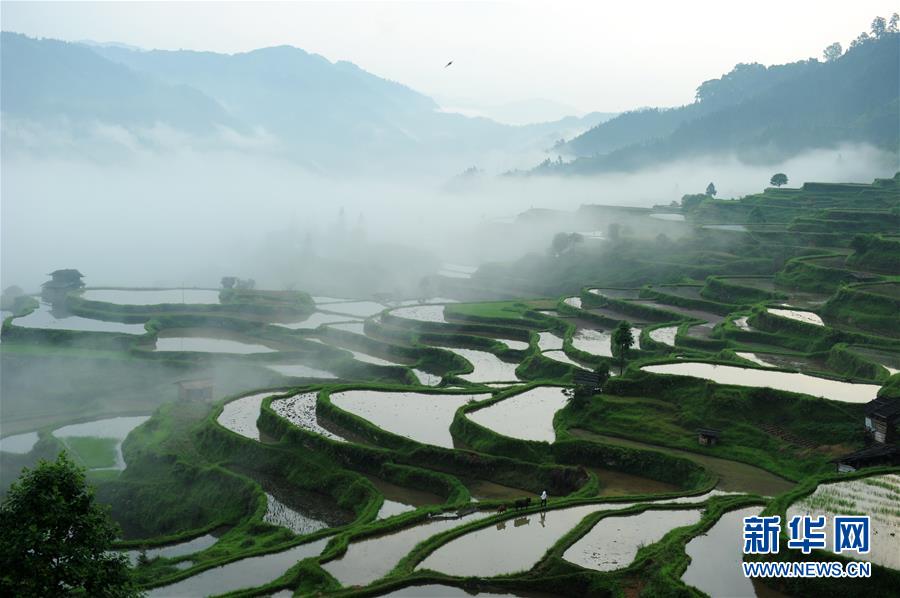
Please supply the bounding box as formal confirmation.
[548,32,900,174]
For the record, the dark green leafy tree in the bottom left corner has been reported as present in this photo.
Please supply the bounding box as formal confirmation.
[0,452,140,597]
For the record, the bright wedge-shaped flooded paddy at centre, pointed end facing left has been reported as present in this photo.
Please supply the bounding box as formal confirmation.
[466,386,566,442]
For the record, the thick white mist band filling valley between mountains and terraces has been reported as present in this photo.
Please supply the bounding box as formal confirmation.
[2,136,898,295]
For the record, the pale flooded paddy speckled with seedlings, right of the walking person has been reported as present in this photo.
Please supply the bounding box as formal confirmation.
[563,509,702,571]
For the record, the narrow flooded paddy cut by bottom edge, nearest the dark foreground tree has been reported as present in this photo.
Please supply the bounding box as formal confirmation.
[147,538,328,598]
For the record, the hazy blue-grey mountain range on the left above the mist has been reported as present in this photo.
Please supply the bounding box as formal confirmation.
[2,32,604,175]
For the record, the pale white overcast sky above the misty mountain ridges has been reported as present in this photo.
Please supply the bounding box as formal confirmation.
[0,0,897,112]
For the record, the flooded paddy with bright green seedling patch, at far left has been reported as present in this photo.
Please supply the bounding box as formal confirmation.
[53,415,150,470]
